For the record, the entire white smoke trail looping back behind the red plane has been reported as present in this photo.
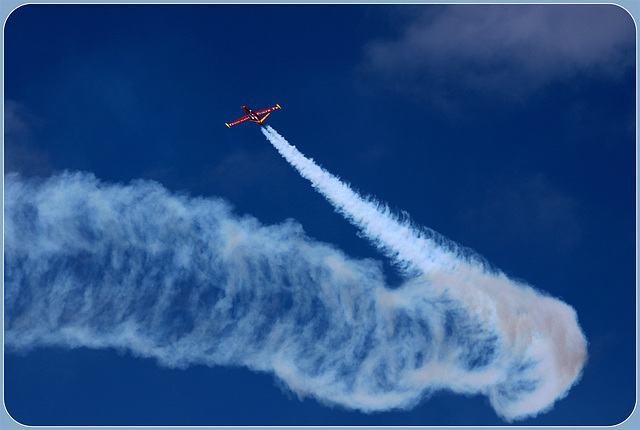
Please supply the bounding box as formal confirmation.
[4,128,586,420]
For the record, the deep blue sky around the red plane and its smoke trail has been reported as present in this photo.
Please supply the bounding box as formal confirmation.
[4,1,636,425]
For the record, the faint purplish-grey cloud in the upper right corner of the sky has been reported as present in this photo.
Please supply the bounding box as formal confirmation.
[362,5,635,100]
